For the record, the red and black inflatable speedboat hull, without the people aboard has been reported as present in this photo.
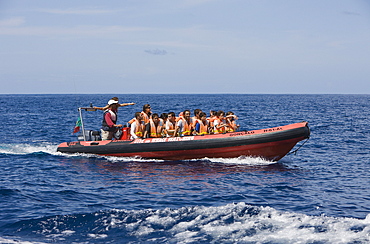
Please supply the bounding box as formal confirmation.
[57,122,310,161]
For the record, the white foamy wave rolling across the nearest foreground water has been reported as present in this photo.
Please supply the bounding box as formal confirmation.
[5,203,370,243]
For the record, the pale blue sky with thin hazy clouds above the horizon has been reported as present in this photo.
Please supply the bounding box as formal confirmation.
[0,0,370,94]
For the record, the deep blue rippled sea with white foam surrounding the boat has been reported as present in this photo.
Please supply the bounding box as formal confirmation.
[0,94,370,244]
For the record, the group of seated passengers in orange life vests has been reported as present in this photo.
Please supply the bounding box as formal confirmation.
[129,104,239,139]
